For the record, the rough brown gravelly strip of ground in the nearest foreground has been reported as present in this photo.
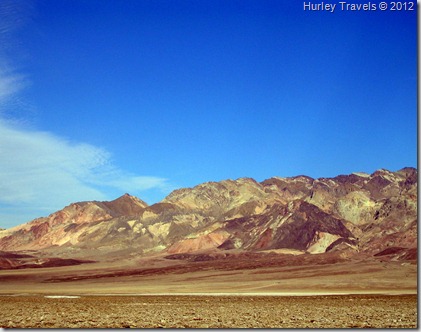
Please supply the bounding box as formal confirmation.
[0,295,418,328]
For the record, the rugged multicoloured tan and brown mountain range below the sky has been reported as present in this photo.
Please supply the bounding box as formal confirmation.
[0,167,418,269]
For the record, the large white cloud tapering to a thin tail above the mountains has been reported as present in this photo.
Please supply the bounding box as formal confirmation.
[0,119,170,225]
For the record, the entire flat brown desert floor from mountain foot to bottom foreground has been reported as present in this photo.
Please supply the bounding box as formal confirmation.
[0,255,418,328]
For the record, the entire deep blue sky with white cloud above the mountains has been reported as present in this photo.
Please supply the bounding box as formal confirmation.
[0,0,417,228]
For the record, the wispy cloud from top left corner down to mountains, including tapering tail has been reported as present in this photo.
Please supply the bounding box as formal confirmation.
[0,0,171,228]
